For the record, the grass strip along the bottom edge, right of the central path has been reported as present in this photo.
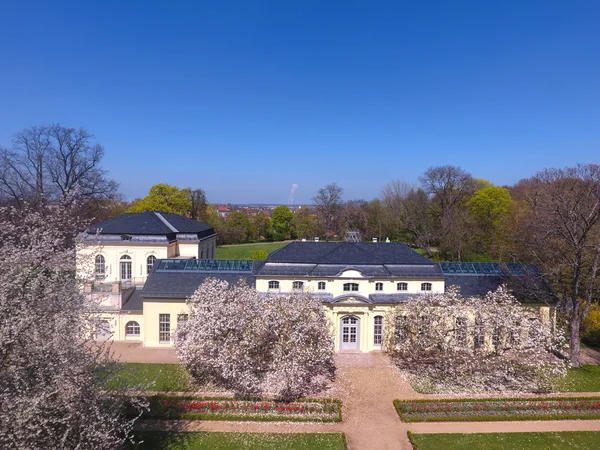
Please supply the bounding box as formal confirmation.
[408,431,600,450]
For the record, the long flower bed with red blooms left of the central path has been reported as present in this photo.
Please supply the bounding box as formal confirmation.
[137,395,342,422]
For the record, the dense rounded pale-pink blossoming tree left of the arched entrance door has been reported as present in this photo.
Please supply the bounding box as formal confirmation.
[175,279,335,401]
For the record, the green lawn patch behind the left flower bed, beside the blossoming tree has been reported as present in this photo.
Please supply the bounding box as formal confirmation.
[109,363,221,392]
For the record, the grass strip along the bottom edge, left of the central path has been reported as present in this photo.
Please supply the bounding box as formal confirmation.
[128,431,346,450]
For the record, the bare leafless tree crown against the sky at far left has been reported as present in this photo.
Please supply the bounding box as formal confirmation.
[0,124,118,207]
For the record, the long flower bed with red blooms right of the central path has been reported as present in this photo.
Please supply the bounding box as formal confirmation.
[394,397,600,422]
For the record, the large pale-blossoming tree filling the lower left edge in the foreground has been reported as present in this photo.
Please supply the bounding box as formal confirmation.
[0,203,147,449]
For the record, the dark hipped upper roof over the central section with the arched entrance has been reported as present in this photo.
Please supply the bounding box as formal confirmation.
[267,242,432,265]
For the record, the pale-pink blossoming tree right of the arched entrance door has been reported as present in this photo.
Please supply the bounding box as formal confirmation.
[384,287,566,394]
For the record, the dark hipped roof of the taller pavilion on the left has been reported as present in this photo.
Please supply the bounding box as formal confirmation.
[86,212,215,237]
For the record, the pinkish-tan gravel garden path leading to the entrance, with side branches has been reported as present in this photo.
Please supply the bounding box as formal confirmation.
[120,343,600,450]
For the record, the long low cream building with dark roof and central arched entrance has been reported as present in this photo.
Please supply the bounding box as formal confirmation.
[77,217,551,352]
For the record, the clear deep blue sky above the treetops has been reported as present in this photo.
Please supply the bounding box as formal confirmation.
[0,0,600,203]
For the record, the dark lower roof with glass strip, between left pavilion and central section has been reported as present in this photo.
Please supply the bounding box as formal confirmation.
[142,270,255,298]
